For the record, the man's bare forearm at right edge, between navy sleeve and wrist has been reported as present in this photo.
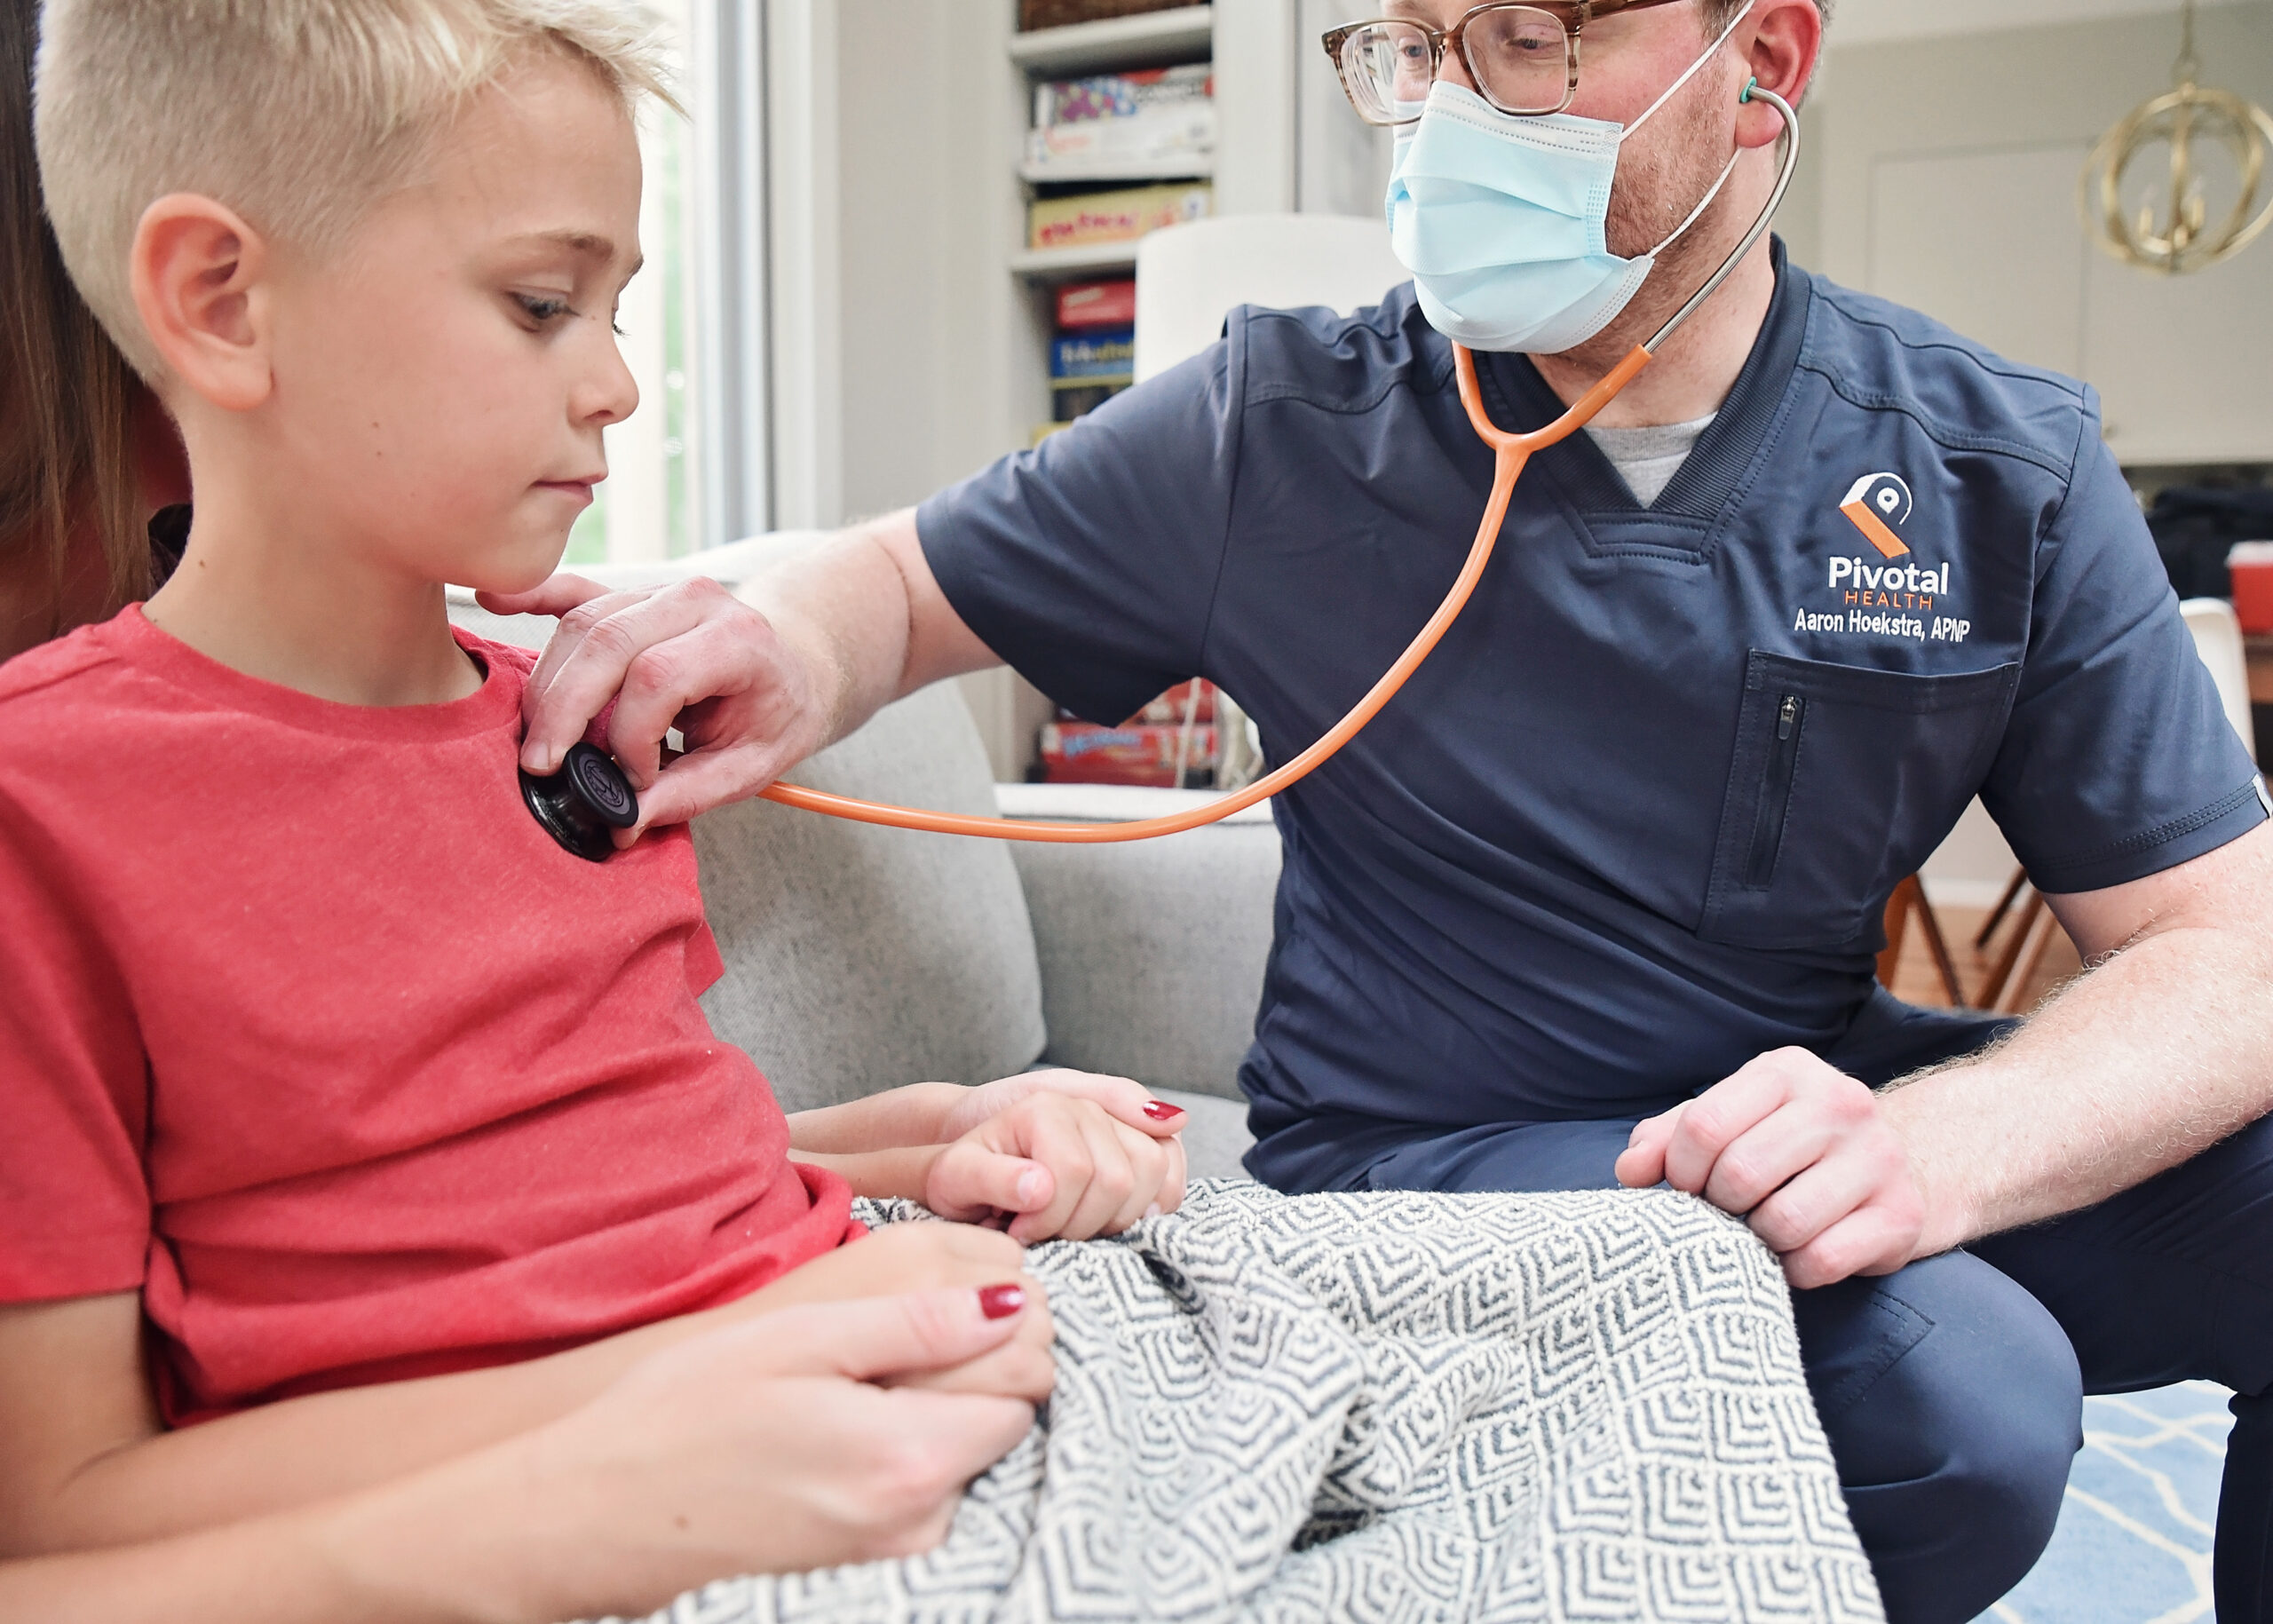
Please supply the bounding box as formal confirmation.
[1884,891,2273,1251]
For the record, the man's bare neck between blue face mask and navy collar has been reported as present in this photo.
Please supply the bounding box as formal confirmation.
[1532,186,1775,428]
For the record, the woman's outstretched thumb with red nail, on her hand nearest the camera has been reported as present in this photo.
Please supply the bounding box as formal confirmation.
[732,1279,1036,1381]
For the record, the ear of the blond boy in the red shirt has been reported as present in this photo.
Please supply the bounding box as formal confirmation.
[131,191,273,412]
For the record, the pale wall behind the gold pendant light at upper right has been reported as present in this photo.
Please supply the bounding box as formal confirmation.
[1814,0,2273,464]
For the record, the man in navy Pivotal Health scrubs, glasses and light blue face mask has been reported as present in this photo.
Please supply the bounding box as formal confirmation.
[497,0,2273,1624]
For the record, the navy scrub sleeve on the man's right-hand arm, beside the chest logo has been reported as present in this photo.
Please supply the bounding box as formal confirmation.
[1982,412,2266,894]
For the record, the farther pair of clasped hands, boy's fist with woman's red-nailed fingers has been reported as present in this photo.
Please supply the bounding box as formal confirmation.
[923,1066,1184,1244]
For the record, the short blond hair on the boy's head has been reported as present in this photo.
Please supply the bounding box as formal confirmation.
[36,0,670,382]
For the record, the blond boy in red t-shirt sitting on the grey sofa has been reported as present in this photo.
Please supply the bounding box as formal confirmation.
[0,0,1182,1551]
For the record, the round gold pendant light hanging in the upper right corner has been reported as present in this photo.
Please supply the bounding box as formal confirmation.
[2079,0,2273,275]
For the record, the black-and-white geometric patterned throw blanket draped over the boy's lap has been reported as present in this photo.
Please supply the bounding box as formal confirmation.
[618,1183,1882,1624]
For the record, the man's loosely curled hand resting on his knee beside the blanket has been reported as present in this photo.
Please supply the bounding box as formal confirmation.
[1619,1049,1948,1289]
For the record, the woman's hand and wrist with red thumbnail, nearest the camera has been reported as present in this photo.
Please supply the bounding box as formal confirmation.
[329,1292,1039,1620]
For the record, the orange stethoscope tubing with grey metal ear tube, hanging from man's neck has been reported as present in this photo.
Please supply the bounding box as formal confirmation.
[759,84,1801,846]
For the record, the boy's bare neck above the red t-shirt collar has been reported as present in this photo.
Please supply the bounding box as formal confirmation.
[146,463,482,705]
